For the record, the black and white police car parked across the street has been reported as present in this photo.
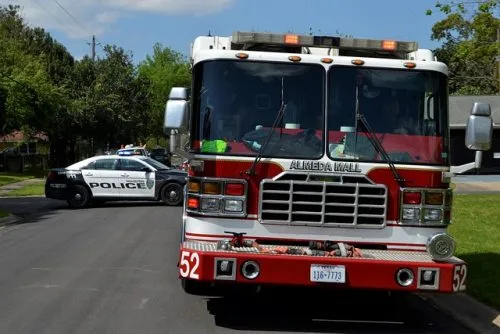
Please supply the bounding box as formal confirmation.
[45,155,187,208]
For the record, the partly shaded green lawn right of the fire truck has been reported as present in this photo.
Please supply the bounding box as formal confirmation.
[449,195,500,309]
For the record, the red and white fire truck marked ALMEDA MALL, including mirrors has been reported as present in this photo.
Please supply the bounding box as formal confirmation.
[164,32,492,294]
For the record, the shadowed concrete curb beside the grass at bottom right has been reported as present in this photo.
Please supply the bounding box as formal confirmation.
[418,293,500,334]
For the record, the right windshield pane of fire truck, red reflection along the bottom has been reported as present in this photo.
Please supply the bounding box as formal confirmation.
[327,66,448,165]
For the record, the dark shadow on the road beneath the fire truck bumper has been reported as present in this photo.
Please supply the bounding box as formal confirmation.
[203,290,471,334]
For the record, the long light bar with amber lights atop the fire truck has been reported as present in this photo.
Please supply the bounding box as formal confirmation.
[232,31,418,52]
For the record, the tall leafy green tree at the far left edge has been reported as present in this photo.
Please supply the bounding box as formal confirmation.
[0,6,76,164]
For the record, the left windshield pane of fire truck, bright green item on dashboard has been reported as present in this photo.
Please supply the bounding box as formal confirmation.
[191,60,326,159]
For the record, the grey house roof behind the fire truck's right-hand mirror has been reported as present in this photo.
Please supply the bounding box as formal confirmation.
[449,95,500,129]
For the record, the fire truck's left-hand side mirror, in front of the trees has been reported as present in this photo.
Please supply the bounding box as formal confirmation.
[163,87,189,134]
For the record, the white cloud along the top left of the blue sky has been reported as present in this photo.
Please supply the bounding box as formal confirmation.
[0,0,236,38]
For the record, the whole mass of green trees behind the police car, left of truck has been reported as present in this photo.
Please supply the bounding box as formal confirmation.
[0,5,189,166]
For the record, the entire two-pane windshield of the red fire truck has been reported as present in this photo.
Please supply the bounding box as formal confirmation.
[190,59,449,165]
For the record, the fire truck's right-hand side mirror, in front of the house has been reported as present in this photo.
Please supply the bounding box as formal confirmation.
[465,102,493,151]
